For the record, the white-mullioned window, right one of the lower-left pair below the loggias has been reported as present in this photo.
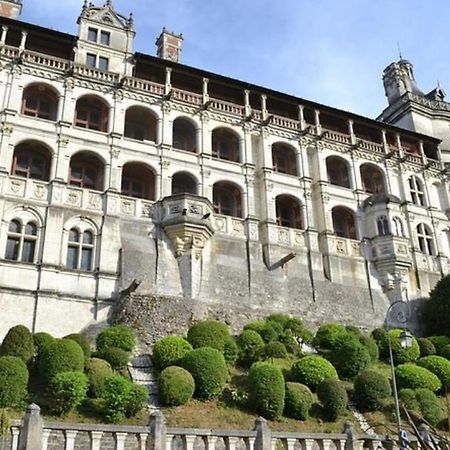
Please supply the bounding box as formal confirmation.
[66,228,94,272]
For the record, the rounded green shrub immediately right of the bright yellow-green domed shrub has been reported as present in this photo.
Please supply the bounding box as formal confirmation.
[331,334,371,379]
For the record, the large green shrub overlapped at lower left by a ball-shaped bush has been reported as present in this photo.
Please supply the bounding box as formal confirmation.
[181,347,228,400]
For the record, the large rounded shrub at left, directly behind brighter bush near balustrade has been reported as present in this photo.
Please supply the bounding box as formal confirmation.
[39,339,84,380]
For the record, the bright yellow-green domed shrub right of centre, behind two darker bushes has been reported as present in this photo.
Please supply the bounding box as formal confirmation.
[291,356,338,391]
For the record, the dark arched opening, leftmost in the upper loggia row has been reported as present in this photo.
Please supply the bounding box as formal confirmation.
[22,84,58,120]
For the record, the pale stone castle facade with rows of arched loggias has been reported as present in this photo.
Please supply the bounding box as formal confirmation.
[0,0,450,342]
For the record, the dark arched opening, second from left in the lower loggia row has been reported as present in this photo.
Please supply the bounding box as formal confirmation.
[69,152,104,191]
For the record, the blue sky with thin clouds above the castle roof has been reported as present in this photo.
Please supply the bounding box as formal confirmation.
[22,0,450,118]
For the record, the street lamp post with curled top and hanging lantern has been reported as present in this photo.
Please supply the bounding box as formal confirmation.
[386,300,412,448]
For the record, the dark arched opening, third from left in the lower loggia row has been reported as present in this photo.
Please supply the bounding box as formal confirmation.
[122,162,156,200]
